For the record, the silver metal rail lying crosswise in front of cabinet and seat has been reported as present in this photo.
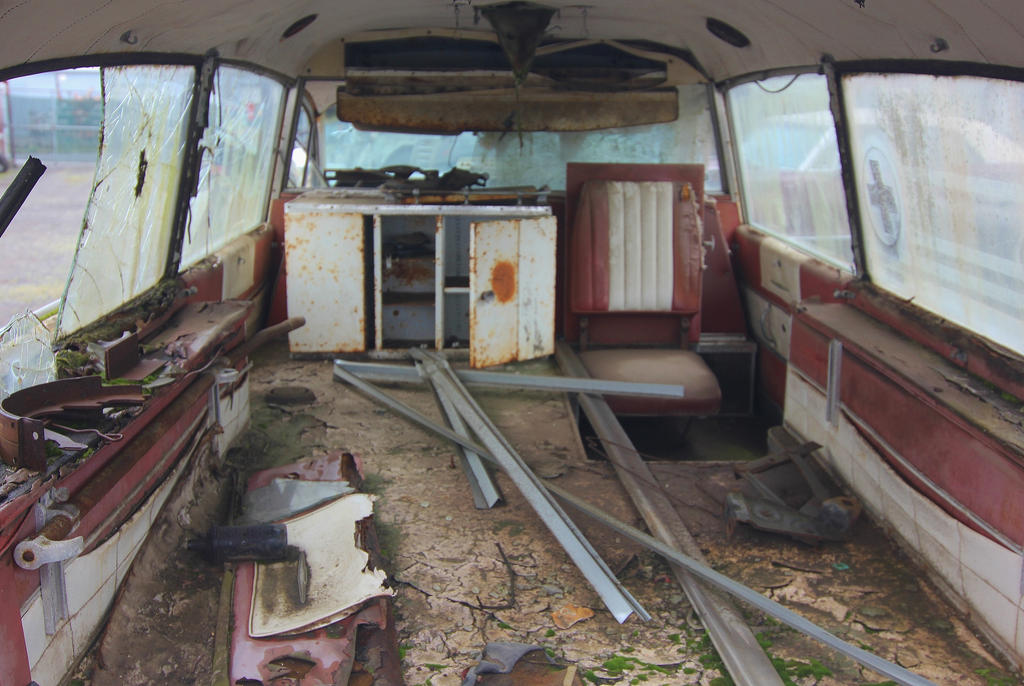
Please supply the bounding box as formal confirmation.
[334,359,685,399]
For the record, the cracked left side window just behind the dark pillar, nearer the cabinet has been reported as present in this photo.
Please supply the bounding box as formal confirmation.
[181,66,285,267]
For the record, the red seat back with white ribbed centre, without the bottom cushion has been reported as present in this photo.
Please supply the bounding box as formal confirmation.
[564,163,703,348]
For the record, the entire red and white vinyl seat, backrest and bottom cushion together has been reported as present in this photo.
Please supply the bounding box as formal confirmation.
[568,165,722,416]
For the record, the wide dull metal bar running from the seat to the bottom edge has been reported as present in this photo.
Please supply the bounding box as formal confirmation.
[555,342,782,686]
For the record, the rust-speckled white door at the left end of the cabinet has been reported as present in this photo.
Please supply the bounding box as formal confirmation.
[285,205,367,352]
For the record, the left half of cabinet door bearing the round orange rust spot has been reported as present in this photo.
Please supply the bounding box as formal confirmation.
[469,219,520,368]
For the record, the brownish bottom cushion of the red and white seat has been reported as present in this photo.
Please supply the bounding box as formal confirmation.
[580,348,722,417]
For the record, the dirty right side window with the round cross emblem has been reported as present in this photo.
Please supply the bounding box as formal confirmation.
[843,74,1024,353]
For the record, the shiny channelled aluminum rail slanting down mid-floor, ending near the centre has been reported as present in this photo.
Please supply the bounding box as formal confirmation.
[412,350,650,624]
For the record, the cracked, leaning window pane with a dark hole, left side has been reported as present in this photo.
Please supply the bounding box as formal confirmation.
[57,66,196,335]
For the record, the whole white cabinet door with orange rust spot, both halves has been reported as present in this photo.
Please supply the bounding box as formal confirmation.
[469,217,556,367]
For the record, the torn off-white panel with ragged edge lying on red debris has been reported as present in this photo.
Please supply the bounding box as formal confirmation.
[249,494,394,638]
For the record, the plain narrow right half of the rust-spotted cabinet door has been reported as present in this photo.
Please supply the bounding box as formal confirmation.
[516,217,557,360]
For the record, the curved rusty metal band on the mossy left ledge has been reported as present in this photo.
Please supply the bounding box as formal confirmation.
[0,377,143,471]
